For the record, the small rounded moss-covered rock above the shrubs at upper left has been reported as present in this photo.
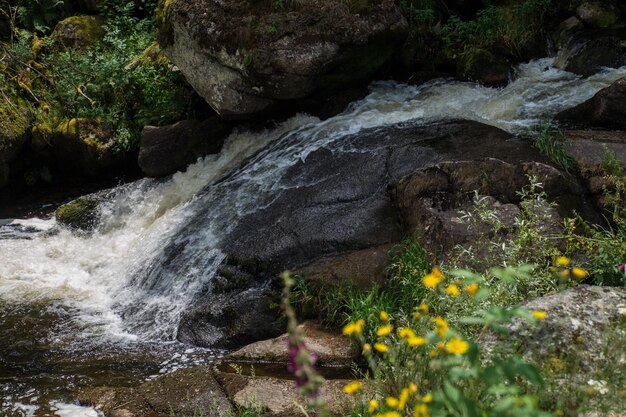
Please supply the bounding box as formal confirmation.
[50,16,105,51]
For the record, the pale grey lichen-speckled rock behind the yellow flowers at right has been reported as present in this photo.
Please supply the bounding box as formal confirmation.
[480,285,626,375]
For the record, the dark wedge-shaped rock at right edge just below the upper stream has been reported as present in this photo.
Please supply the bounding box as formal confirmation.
[556,77,626,130]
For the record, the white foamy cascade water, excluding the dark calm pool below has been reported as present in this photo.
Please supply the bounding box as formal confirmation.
[0,59,626,341]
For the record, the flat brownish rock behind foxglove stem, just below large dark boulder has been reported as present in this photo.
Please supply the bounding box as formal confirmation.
[224,321,358,366]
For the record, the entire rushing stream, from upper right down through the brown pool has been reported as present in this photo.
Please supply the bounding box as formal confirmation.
[0,59,626,417]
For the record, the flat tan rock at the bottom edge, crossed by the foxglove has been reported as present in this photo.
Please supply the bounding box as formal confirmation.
[216,373,355,417]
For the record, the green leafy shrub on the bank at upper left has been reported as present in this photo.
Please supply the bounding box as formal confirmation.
[5,0,191,151]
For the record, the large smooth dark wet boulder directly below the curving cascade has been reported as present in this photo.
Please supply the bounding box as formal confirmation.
[173,121,579,348]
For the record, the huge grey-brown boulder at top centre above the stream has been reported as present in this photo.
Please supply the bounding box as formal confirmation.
[158,0,408,117]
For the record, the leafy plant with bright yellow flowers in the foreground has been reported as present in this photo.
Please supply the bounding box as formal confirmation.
[344,267,550,417]
